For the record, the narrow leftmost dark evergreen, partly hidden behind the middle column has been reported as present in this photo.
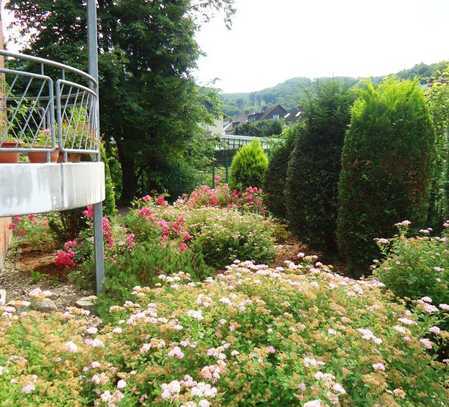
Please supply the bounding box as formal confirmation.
[263,125,301,219]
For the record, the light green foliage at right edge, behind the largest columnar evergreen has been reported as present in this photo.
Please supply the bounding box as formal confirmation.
[427,68,449,229]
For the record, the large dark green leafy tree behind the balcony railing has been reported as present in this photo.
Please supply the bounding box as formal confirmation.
[7,0,234,202]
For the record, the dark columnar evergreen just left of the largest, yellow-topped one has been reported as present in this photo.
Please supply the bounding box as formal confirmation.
[286,81,354,252]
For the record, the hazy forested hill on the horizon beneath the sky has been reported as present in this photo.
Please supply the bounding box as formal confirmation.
[222,61,447,116]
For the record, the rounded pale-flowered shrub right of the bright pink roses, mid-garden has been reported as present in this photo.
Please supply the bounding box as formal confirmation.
[186,209,275,269]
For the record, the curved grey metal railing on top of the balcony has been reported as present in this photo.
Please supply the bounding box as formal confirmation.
[0,50,100,161]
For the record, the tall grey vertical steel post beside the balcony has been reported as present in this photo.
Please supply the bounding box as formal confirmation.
[87,0,104,294]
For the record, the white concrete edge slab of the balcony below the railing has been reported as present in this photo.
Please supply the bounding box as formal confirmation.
[0,162,105,217]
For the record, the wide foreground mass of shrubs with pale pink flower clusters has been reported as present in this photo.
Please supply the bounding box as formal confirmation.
[0,259,449,407]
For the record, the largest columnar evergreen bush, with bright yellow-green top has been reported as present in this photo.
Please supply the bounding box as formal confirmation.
[337,79,435,277]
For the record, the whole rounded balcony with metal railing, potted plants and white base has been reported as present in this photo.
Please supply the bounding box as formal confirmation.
[0,50,105,217]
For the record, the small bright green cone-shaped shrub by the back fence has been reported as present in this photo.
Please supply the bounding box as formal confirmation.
[231,140,268,190]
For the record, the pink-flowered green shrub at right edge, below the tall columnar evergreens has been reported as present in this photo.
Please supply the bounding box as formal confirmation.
[374,224,449,306]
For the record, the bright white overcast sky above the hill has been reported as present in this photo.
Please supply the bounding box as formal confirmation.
[197,0,449,92]
